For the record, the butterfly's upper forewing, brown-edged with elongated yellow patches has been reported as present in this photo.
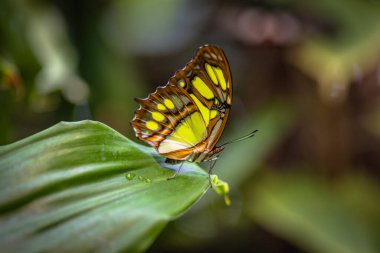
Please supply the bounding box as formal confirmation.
[169,45,232,150]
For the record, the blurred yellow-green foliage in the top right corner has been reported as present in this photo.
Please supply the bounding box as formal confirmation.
[289,0,380,103]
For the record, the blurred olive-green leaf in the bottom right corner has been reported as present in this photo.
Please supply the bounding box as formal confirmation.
[247,171,380,253]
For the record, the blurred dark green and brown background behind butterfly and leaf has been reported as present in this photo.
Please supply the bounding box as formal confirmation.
[0,0,380,253]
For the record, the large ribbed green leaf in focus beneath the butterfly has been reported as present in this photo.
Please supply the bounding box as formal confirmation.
[0,121,209,252]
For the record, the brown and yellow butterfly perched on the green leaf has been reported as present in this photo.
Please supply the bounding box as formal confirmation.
[131,45,232,162]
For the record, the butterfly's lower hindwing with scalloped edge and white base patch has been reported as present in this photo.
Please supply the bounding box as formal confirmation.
[131,84,207,160]
